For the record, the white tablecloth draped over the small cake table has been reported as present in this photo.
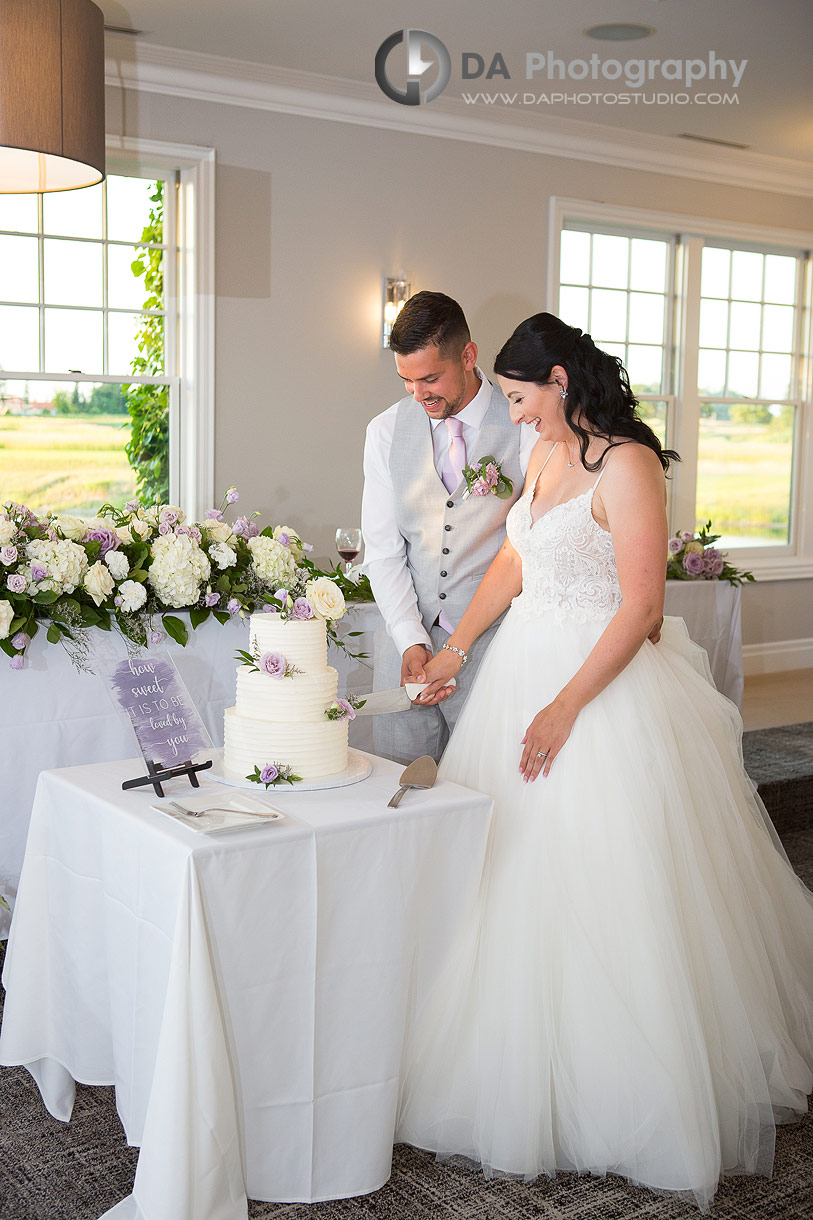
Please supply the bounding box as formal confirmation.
[0,760,492,1220]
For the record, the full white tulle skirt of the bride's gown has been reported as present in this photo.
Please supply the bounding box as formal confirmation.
[397,610,813,1209]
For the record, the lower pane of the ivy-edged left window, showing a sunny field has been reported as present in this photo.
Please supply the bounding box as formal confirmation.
[0,381,136,516]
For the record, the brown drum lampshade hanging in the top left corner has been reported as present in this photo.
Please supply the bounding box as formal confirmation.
[0,0,105,194]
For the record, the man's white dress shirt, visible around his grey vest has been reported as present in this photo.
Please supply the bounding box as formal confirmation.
[361,368,538,655]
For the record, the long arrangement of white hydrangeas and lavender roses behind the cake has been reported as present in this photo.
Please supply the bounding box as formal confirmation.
[0,487,365,670]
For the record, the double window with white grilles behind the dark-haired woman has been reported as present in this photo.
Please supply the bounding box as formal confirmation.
[551,200,813,577]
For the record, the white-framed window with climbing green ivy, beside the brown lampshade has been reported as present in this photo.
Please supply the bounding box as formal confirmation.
[0,140,214,515]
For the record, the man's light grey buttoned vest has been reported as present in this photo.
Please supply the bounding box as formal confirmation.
[389,386,522,631]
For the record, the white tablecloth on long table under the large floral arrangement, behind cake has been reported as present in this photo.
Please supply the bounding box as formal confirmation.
[0,606,378,937]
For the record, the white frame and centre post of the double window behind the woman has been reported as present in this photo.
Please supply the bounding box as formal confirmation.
[547,196,813,581]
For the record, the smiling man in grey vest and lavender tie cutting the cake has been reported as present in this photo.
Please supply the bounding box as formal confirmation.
[361,292,537,763]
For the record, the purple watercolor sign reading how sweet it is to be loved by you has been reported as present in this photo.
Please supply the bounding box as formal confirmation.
[107,653,212,767]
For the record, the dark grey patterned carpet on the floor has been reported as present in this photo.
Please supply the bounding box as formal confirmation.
[0,814,813,1220]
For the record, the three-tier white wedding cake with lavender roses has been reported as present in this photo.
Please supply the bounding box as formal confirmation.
[223,614,348,780]
